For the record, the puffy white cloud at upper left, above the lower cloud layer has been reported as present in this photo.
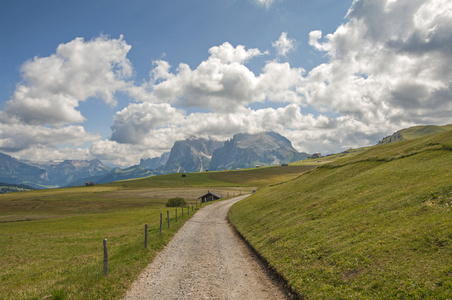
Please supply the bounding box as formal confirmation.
[4,36,132,125]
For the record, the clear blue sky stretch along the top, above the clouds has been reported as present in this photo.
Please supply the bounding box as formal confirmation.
[0,0,352,95]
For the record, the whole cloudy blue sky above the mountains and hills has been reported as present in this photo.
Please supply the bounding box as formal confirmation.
[0,0,452,167]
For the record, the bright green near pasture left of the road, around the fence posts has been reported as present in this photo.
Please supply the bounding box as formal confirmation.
[0,205,187,299]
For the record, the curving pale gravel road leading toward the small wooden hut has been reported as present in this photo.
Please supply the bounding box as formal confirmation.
[124,196,287,300]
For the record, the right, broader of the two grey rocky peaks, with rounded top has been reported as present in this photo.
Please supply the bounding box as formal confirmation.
[210,132,308,170]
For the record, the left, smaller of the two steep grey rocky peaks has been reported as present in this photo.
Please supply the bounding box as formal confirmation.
[162,139,223,173]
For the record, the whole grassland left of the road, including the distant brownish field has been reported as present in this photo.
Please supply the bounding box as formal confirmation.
[0,167,306,299]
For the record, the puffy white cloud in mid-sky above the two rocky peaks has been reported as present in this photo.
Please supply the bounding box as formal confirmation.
[147,43,304,113]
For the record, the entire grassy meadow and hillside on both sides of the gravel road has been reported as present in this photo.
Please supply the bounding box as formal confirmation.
[0,127,452,299]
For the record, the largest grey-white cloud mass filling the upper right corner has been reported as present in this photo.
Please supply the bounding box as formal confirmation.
[297,0,452,132]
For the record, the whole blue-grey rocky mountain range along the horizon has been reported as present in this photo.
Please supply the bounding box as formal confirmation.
[0,132,309,189]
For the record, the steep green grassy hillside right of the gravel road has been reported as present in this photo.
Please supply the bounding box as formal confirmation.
[230,131,452,299]
